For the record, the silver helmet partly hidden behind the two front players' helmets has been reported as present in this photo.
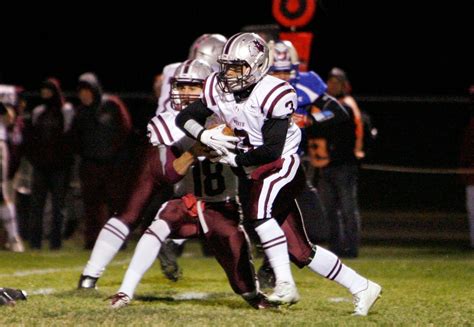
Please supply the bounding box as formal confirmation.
[188,34,227,71]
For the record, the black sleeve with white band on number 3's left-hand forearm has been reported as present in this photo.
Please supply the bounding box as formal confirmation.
[176,100,213,139]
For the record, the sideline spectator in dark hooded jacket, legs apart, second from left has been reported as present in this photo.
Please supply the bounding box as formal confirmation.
[24,78,74,250]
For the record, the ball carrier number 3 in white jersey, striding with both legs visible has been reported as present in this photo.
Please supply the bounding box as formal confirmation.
[176,33,381,315]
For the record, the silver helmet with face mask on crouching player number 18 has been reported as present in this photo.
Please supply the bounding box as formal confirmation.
[170,59,212,111]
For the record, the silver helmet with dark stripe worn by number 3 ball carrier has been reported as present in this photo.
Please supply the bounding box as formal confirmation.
[217,33,269,93]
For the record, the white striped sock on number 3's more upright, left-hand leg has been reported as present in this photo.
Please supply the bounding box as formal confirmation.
[255,218,295,285]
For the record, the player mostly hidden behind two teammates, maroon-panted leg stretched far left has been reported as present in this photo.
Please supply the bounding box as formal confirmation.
[78,34,225,289]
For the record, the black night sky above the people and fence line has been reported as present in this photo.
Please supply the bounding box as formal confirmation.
[0,0,474,95]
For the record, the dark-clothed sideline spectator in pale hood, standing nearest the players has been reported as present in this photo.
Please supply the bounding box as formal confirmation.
[72,73,132,249]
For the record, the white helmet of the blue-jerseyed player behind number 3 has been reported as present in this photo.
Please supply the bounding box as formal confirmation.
[268,41,300,79]
